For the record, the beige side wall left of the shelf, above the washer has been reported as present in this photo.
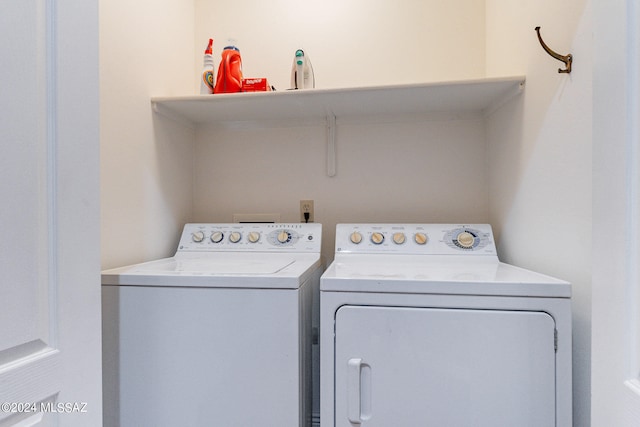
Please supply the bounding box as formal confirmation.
[100,0,194,268]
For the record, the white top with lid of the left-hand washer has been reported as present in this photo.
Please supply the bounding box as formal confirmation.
[102,252,320,289]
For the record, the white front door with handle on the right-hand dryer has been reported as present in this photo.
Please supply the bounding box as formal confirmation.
[335,306,555,427]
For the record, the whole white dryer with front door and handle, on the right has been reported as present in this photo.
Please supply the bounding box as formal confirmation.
[320,224,572,427]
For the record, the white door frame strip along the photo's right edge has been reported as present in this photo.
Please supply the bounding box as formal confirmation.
[592,0,640,427]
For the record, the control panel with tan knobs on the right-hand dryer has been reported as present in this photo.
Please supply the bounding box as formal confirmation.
[336,224,496,256]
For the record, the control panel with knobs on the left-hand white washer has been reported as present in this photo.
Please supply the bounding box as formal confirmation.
[178,223,322,252]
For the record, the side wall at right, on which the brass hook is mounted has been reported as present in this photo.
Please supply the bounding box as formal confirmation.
[486,0,593,427]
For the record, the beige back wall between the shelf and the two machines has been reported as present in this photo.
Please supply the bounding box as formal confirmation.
[194,115,488,261]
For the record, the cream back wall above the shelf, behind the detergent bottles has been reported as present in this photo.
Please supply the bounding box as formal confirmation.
[194,0,485,90]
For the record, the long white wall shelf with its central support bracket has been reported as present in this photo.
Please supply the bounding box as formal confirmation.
[151,76,525,176]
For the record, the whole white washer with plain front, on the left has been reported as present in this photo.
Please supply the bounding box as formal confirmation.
[102,224,322,427]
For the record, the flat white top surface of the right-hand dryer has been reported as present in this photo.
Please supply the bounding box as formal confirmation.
[320,254,571,298]
